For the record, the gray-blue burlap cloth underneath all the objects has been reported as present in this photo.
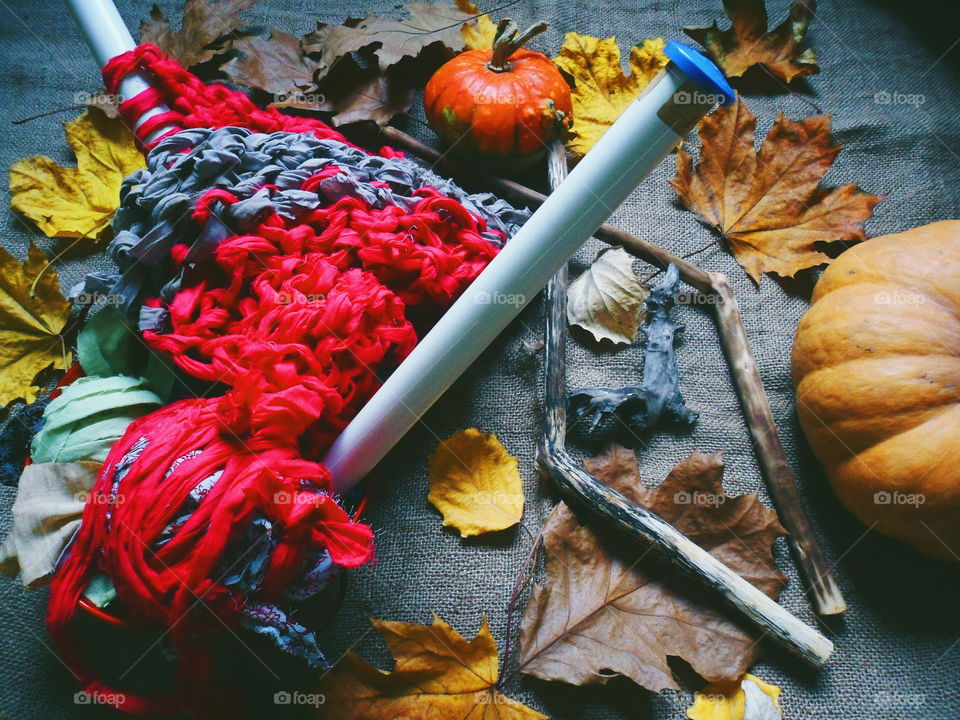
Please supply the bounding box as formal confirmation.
[0,0,960,720]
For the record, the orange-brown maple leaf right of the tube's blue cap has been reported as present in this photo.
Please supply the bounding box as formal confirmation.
[670,99,882,282]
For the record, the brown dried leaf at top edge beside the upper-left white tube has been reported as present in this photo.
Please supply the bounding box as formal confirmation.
[140,0,254,68]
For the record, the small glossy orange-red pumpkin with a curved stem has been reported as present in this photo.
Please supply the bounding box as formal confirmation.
[423,20,572,158]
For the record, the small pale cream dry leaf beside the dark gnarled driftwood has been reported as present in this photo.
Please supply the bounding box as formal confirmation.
[567,247,649,345]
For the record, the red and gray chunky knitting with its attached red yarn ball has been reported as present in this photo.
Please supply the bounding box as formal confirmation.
[48,46,524,717]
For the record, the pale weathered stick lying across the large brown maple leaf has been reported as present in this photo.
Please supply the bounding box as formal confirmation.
[537,143,833,666]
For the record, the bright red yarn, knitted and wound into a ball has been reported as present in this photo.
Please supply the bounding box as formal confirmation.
[47,45,496,718]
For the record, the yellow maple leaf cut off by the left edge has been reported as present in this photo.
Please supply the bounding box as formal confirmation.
[0,243,70,405]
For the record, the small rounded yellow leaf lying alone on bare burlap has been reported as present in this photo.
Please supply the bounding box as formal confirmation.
[427,428,523,537]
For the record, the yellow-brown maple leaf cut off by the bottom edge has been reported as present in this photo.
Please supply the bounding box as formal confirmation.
[319,615,547,720]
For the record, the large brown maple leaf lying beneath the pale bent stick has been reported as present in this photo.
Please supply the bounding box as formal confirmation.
[520,445,786,692]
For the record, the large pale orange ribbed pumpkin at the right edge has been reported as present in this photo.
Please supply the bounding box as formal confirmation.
[792,220,960,561]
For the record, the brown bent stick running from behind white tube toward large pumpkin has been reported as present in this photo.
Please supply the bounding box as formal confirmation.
[383,127,847,615]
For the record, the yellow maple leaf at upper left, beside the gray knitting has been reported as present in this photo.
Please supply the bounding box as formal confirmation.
[10,108,146,249]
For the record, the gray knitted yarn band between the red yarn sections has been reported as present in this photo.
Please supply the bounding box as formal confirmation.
[71,127,529,330]
